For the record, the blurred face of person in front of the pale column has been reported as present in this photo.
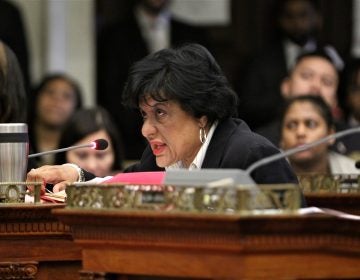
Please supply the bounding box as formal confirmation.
[37,79,77,127]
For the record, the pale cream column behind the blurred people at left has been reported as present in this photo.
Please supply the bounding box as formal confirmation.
[11,0,96,106]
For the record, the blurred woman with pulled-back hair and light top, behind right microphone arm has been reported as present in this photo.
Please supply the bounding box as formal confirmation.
[280,95,360,175]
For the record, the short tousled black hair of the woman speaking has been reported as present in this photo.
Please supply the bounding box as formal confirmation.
[123,44,237,123]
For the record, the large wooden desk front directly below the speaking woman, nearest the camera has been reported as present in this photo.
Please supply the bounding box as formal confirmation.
[53,209,360,280]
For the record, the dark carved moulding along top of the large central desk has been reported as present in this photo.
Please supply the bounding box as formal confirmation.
[55,209,360,254]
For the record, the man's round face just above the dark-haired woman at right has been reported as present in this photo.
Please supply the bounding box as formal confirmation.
[281,56,339,108]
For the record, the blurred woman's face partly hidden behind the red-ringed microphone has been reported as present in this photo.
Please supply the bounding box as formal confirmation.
[66,130,115,177]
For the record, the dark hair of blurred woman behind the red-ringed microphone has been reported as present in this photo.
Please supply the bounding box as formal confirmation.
[55,107,124,170]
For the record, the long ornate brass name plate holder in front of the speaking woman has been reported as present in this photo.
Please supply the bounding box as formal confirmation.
[66,183,301,215]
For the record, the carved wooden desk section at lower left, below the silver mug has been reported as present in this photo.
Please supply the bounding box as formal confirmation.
[0,204,81,280]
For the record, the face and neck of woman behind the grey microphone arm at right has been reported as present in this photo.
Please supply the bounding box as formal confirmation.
[280,101,333,162]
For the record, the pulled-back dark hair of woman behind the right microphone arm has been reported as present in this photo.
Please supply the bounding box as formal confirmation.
[280,95,335,130]
